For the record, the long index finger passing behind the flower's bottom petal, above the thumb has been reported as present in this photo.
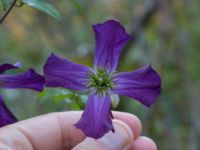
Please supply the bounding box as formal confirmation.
[0,111,141,150]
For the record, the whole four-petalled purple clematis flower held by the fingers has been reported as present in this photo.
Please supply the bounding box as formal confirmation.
[44,20,161,139]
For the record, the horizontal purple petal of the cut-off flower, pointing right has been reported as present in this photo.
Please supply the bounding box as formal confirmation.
[0,69,45,91]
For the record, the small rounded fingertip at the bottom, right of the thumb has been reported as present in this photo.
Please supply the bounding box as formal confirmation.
[132,136,157,150]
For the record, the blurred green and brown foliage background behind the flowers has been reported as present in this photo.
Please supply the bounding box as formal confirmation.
[0,0,200,150]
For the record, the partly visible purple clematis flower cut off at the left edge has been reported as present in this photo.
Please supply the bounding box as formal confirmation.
[0,63,45,127]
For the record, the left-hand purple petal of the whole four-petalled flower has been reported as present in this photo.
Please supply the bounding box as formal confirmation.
[44,54,90,90]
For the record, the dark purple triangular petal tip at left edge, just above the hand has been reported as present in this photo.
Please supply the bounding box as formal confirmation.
[0,96,17,127]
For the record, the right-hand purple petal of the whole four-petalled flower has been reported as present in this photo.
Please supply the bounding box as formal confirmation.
[114,65,161,107]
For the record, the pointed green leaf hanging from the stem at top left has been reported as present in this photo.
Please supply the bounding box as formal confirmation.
[22,0,61,21]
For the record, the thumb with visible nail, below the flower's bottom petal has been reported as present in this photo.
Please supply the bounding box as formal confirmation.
[72,120,133,150]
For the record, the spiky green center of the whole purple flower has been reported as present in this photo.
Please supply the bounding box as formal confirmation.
[89,68,114,95]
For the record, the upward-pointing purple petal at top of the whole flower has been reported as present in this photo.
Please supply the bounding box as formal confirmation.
[93,20,131,71]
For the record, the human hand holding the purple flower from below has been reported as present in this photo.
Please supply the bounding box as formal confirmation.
[0,111,157,150]
